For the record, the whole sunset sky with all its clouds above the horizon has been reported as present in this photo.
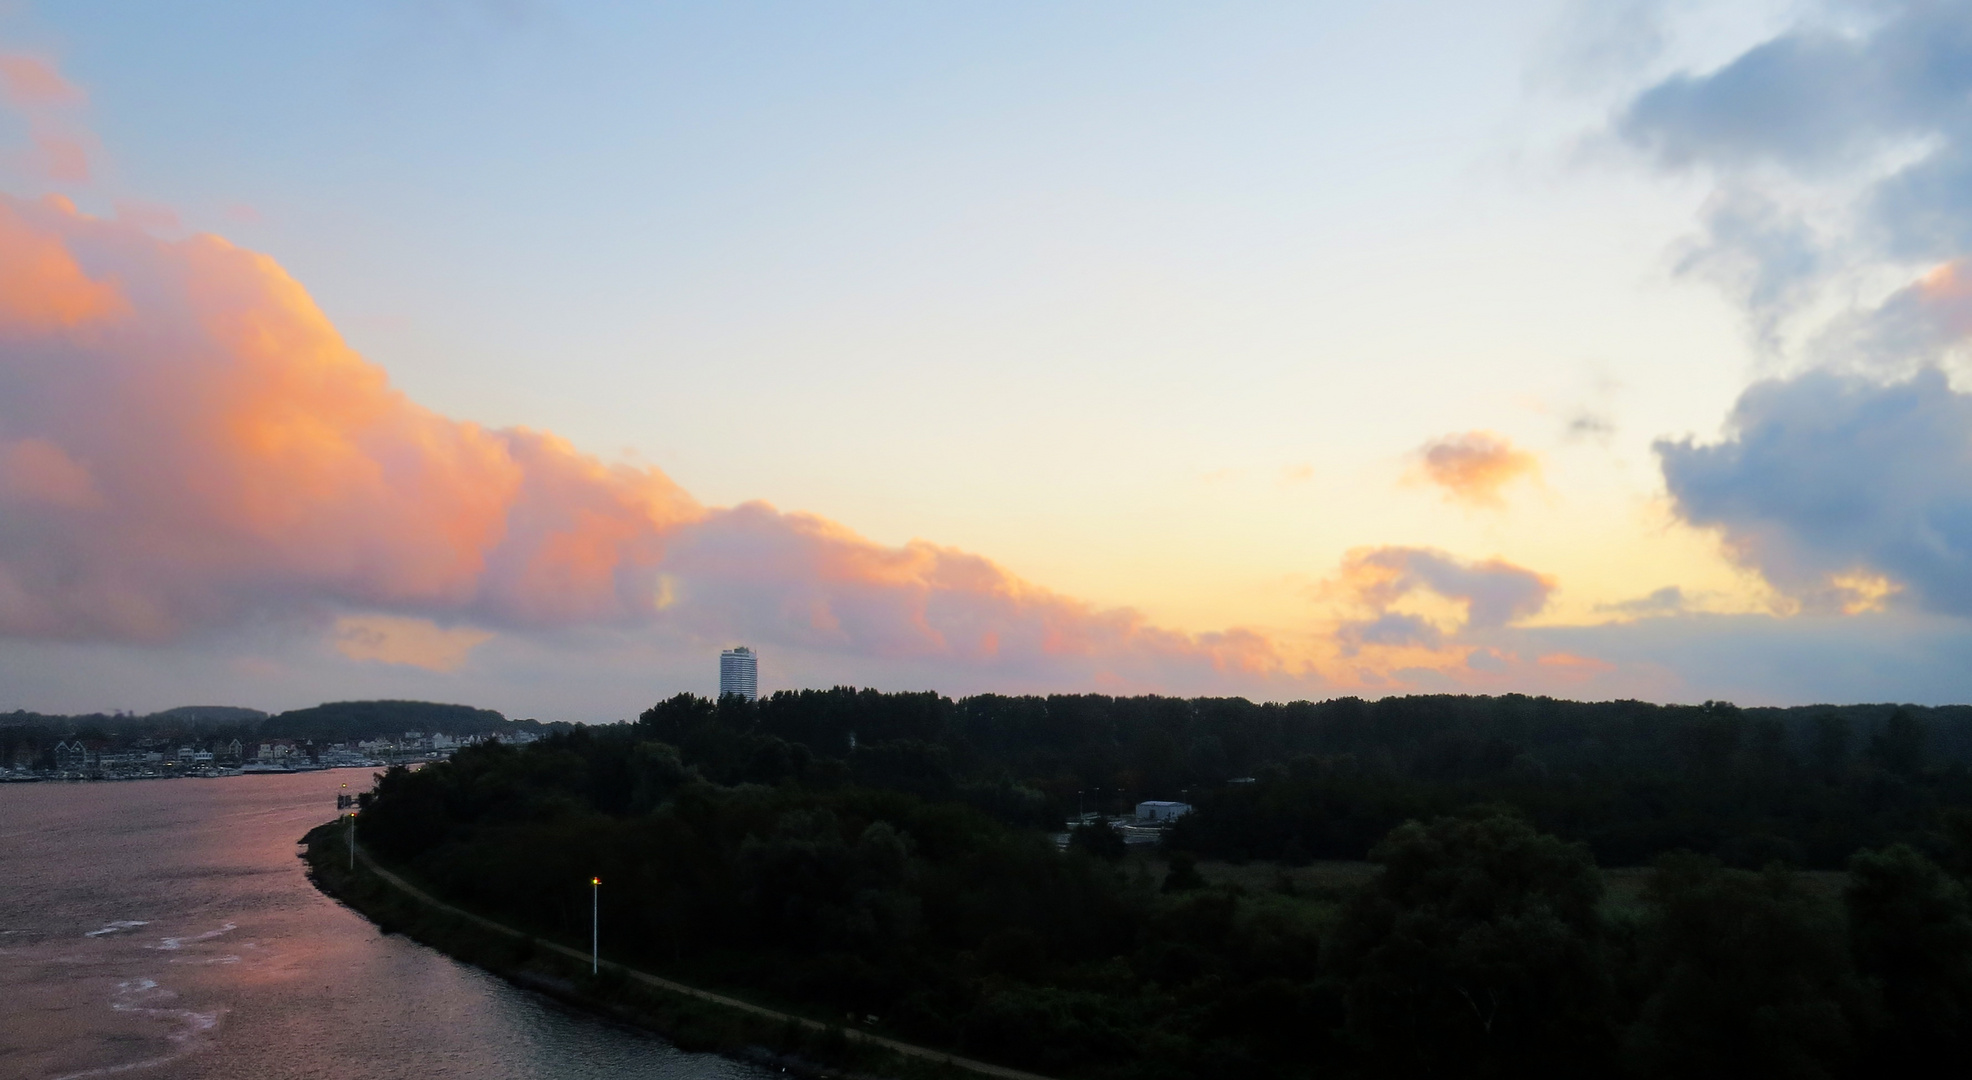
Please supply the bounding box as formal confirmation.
[0,0,1972,721]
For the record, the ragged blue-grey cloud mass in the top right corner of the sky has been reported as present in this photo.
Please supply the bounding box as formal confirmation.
[1613,0,1972,364]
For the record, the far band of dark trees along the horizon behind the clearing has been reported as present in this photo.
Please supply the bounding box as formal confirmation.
[639,688,1972,869]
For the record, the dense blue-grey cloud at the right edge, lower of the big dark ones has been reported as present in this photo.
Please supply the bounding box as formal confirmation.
[1656,369,1972,617]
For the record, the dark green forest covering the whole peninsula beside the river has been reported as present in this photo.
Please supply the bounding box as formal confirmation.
[359,688,1972,1078]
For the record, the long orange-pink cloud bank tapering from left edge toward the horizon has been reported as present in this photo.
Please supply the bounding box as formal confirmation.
[0,197,1294,686]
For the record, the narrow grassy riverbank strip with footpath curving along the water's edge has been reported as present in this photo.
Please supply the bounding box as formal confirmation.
[298,822,1051,1080]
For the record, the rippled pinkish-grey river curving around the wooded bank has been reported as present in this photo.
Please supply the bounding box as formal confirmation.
[0,769,779,1080]
